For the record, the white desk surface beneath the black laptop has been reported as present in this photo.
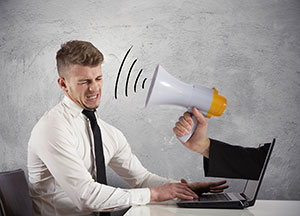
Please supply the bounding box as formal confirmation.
[125,200,300,216]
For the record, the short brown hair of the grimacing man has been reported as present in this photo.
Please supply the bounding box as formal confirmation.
[56,40,104,76]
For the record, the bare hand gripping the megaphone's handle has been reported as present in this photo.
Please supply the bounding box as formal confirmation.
[173,107,210,158]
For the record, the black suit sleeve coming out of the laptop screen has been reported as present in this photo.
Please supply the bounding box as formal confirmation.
[203,139,270,180]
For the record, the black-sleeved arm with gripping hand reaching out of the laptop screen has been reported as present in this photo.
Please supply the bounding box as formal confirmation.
[173,107,270,180]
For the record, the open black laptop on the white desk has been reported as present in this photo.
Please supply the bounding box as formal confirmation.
[176,138,276,209]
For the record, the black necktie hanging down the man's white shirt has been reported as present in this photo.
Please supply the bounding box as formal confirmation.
[82,110,107,184]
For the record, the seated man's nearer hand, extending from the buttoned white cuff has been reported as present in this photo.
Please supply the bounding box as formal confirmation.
[150,183,198,202]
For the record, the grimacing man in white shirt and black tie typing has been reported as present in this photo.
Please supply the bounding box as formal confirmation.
[28,41,227,215]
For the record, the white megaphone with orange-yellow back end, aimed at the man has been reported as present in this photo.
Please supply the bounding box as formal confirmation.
[145,65,227,142]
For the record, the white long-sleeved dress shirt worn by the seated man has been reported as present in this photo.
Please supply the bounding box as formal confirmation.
[28,96,174,216]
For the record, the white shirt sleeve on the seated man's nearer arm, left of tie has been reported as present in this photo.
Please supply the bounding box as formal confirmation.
[30,119,150,211]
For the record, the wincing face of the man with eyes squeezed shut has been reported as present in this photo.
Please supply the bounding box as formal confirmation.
[58,64,103,110]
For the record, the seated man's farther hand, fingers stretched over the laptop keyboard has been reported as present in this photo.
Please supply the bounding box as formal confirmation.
[181,179,228,196]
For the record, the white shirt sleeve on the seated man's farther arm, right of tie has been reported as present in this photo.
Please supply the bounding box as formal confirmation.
[109,126,177,188]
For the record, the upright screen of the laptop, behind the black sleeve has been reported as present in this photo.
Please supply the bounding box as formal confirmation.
[243,139,276,200]
